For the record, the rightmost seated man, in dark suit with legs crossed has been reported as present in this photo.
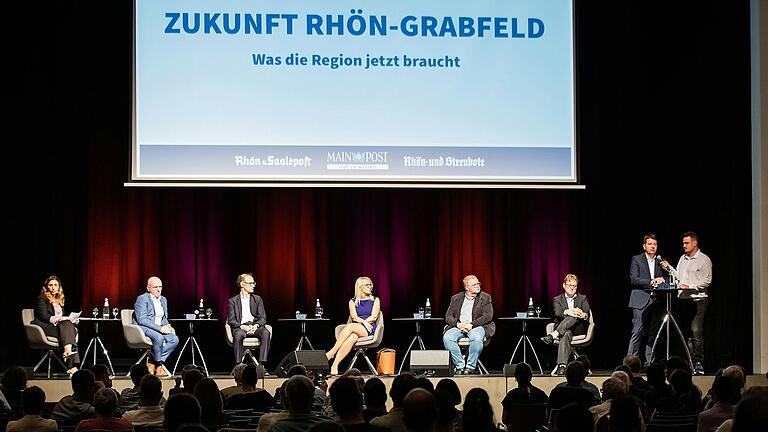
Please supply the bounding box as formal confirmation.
[541,273,590,375]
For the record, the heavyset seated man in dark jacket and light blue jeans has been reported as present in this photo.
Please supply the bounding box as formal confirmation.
[443,275,496,375]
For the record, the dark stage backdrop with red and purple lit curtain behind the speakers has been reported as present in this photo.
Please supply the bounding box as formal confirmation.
[0,1,752,371]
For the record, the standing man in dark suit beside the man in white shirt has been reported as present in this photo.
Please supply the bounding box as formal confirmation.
[627,234,664,365]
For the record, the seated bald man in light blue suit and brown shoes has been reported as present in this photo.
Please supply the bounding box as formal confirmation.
[133,276,179,378]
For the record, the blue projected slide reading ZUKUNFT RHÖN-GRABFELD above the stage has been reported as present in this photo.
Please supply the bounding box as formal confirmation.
[132,0,577,185]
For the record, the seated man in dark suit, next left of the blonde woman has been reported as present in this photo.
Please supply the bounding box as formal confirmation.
[227,273,271,366]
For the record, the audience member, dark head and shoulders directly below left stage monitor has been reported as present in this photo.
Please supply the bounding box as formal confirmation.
[269,375,327,432]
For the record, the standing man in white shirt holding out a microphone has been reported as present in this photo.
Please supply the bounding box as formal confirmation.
[661,231,712,375]
